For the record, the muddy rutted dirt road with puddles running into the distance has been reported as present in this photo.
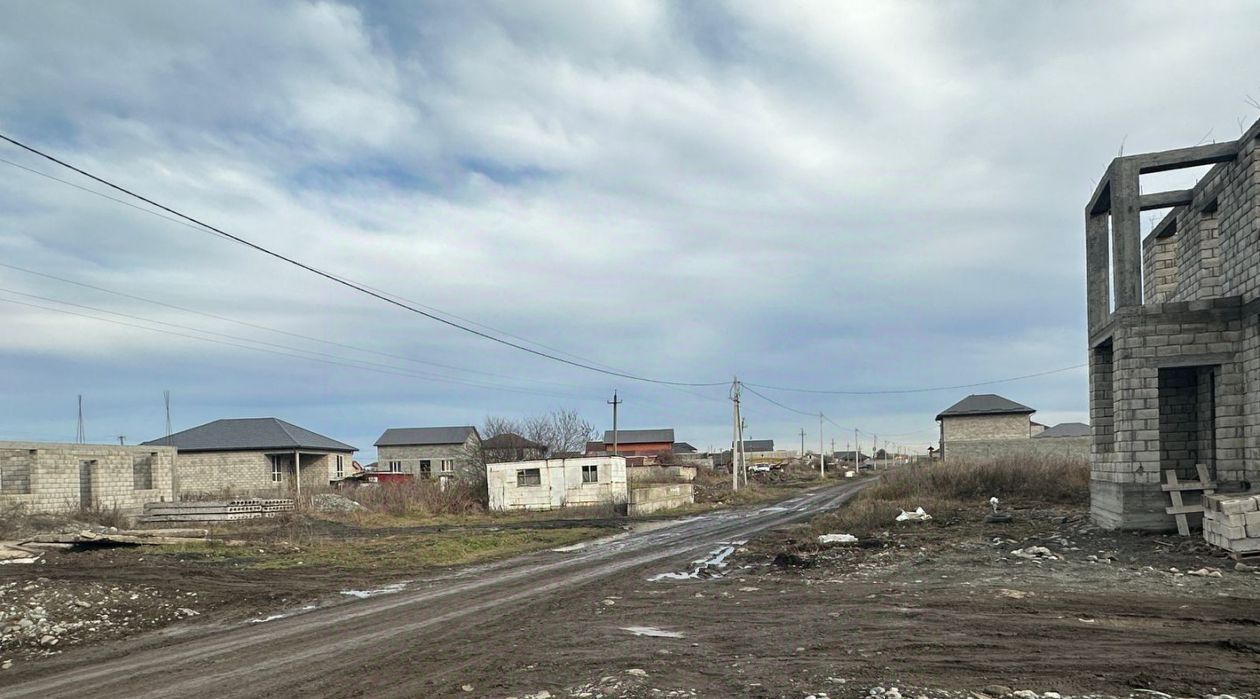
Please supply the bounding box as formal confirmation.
[0,484,861,698]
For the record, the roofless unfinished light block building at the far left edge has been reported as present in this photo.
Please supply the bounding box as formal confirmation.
[0,442,175,514]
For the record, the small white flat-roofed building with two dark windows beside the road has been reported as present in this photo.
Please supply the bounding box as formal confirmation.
[485,456,630,510]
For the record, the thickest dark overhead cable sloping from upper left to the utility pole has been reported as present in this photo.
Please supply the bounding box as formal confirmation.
[0,134,726,387]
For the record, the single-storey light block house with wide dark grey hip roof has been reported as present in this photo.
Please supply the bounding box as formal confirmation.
[144,417,358,497]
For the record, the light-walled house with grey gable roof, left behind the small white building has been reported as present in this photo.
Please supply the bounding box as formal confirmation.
[375,426,485,479]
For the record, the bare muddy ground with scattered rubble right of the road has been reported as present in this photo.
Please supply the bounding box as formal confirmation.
[509,509,1260,699]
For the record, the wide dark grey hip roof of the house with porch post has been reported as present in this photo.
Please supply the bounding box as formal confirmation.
[145,417,358,452]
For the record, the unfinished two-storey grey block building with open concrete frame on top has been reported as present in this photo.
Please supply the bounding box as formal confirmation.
[1085,122,1260,530]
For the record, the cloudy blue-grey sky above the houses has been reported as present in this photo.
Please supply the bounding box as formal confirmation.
[0,0,1260,461]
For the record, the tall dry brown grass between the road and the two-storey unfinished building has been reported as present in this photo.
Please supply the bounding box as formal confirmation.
[813,458,1090,537]
